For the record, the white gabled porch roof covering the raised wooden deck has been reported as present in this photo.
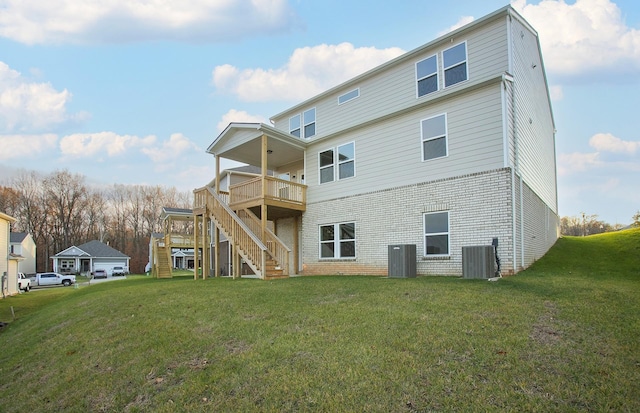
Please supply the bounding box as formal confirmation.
[207,122,307,170]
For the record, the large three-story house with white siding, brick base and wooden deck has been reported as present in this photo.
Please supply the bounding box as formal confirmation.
[193,6,559,278]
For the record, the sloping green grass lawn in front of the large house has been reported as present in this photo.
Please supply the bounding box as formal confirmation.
[0,230,640,412]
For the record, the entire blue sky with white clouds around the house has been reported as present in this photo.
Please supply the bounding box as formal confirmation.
[0,0,640,224]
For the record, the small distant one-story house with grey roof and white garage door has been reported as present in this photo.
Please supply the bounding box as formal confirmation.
[52,240,130,275]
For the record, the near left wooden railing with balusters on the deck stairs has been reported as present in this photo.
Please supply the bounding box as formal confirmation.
[206,188,268,278]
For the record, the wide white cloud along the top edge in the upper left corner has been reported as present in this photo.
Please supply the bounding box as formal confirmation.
[0,0,299,44]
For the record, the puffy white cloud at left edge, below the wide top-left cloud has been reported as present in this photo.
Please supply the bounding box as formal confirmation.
[0,61,86,133]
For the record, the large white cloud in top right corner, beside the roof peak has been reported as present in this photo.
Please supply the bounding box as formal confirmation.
[511,0,640,79]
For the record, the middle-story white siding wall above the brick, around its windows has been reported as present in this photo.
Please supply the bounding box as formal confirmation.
[306,84,504,202]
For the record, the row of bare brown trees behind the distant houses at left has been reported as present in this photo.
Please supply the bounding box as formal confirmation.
[0,170,193,273]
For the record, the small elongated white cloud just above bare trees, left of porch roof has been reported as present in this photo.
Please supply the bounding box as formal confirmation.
[60,132,156,159]
